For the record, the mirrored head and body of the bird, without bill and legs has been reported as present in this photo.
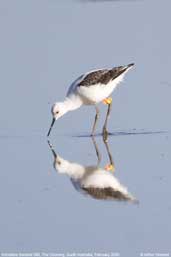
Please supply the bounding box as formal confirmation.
[54,151,136,202]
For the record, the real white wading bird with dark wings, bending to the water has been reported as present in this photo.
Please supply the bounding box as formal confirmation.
[47,63,134,137]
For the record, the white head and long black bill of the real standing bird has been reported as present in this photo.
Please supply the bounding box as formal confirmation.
[47,102,67,136]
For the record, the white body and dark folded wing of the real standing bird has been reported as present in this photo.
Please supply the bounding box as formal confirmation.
[67,64,133,104]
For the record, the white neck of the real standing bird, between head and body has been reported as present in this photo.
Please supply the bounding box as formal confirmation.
[63,95,83,112]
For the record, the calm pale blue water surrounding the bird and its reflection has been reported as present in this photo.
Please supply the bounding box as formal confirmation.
[0,0,171,253]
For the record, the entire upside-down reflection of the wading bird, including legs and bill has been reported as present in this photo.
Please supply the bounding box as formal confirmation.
[48,138,138,203]
